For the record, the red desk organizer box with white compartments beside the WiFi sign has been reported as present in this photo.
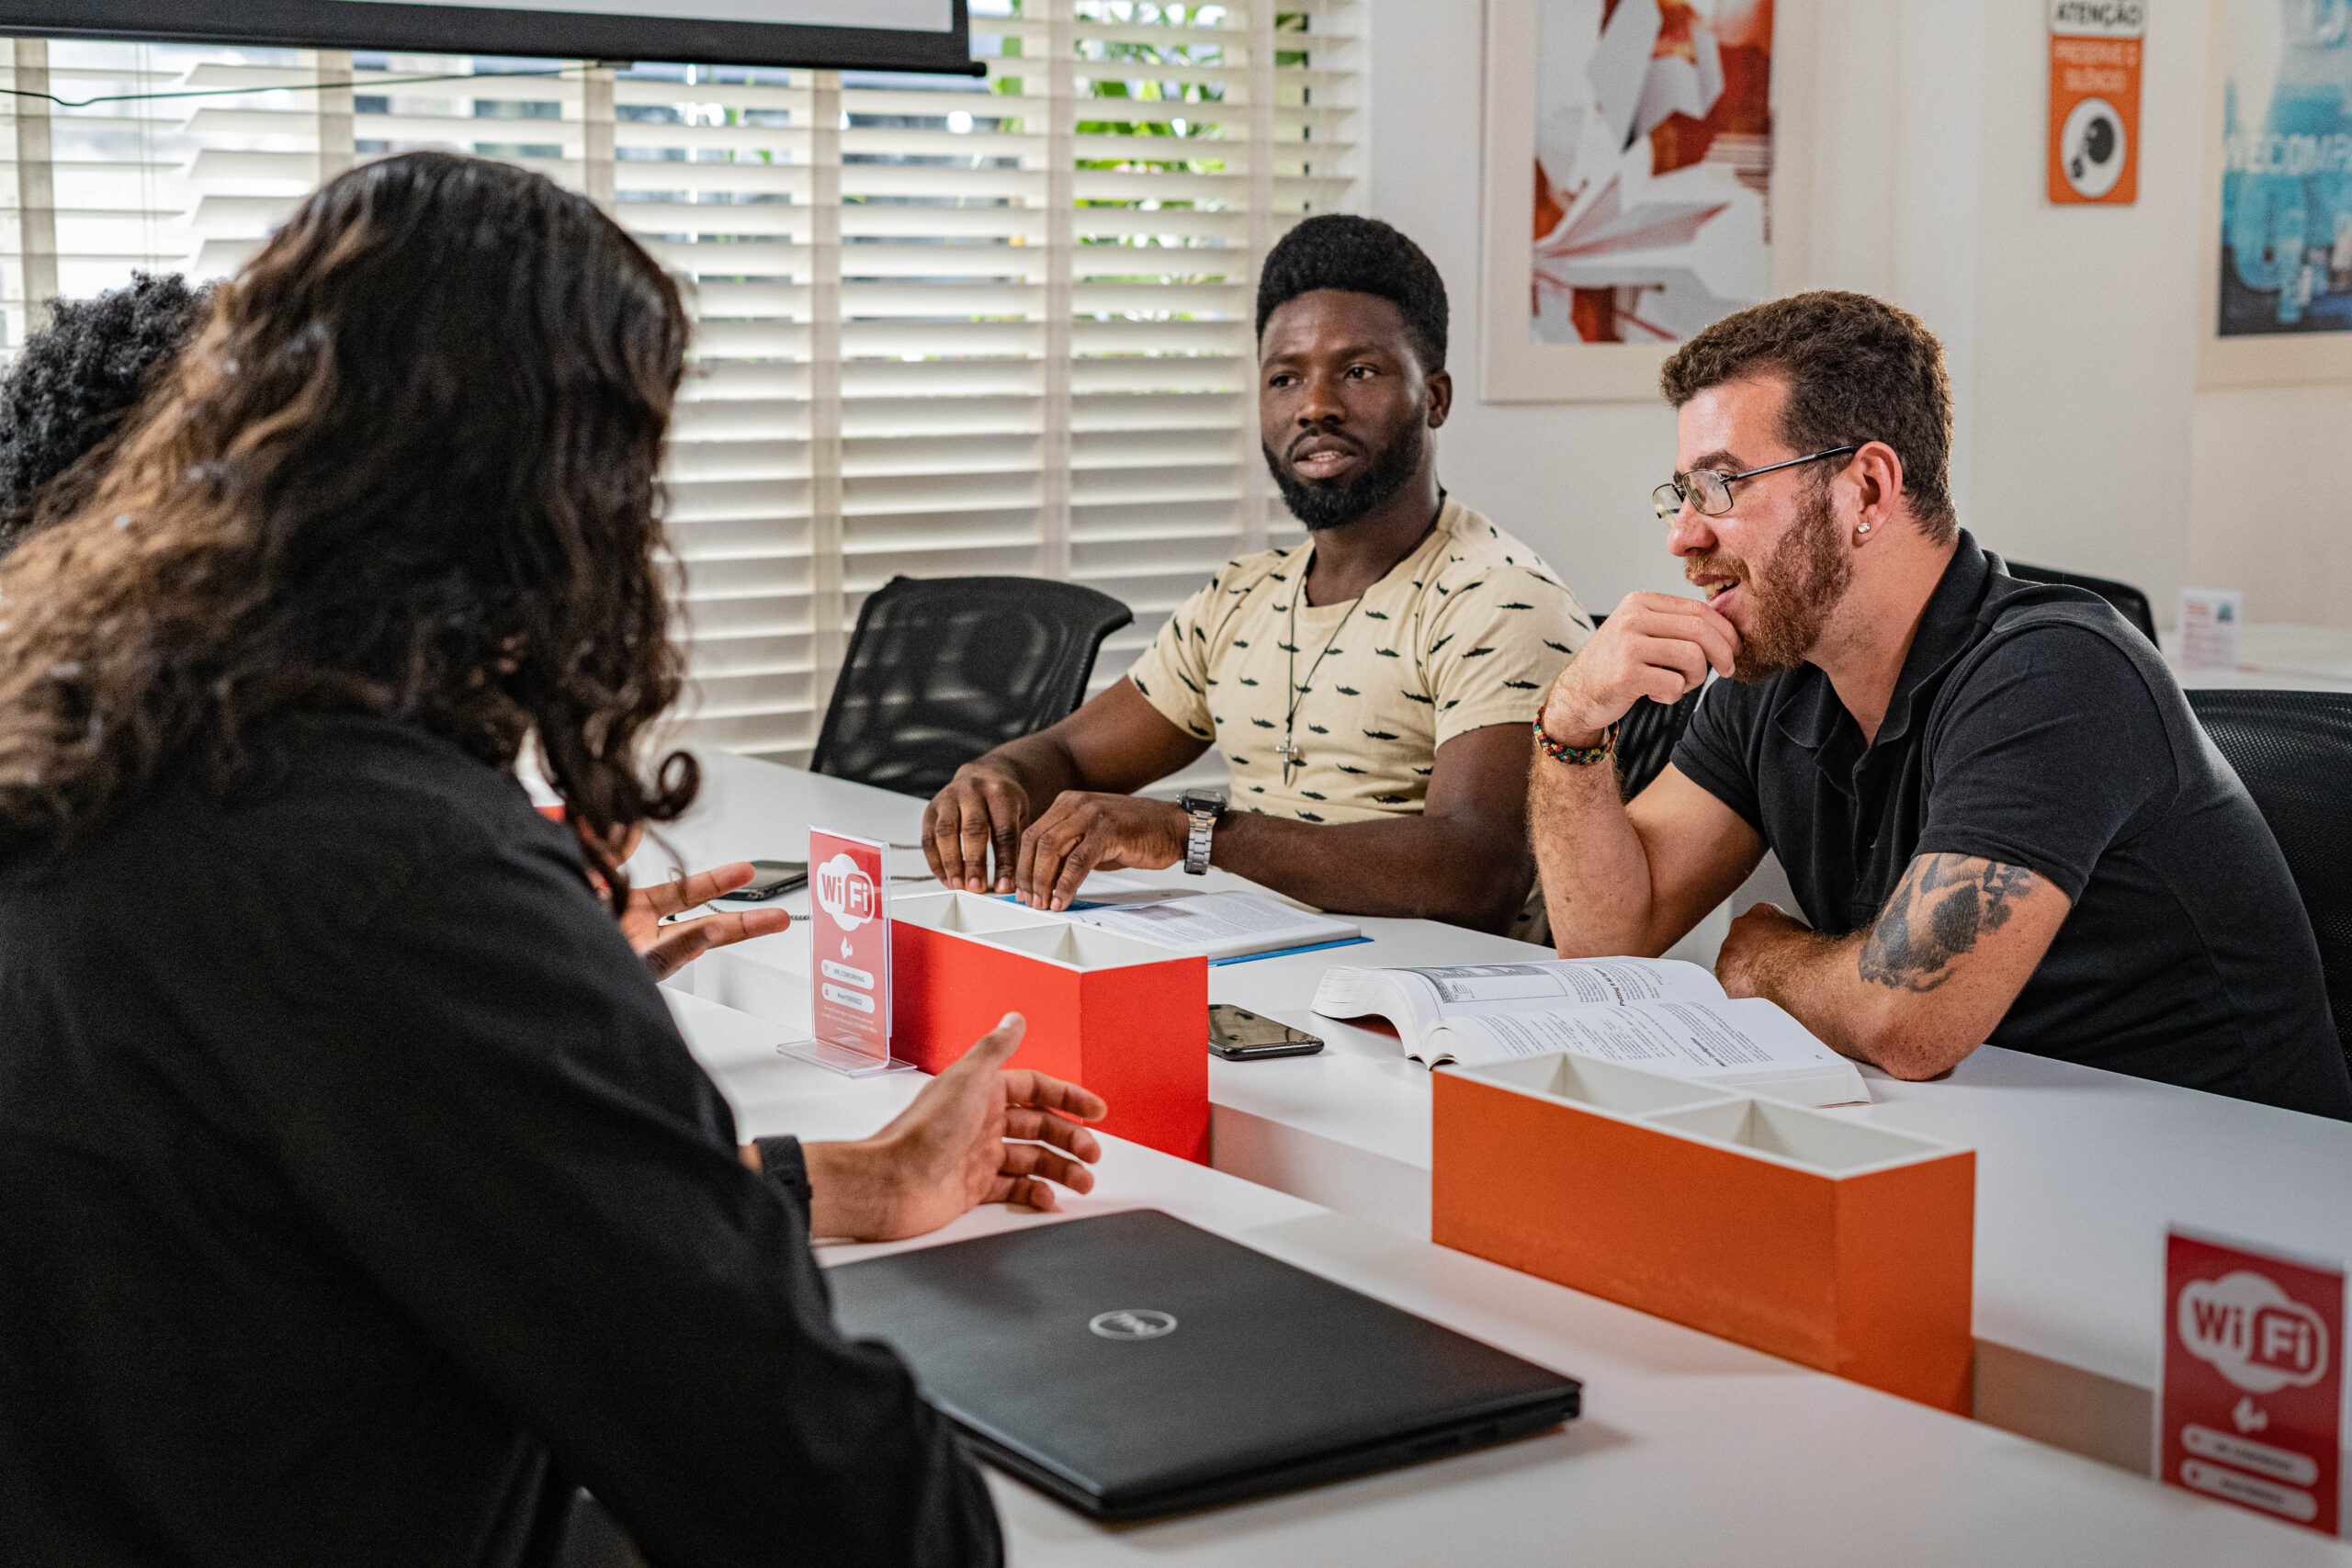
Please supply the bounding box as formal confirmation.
[891,894,1209,1164]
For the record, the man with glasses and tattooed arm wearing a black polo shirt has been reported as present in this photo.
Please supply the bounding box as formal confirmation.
[1532,294,2352,1117]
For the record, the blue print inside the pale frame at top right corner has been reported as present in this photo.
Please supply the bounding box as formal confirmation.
[2218,0,2352,339]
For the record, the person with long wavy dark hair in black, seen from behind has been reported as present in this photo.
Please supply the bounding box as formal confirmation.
[0,152,1103,1563]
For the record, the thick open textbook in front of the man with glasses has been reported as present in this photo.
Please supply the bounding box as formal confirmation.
[1315,959,1870,1105]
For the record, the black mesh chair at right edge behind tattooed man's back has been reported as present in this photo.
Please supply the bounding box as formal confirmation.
[2188,691,2352,1063]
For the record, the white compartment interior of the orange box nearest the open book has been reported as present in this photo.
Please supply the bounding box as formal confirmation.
[1449,1055,1964,1178]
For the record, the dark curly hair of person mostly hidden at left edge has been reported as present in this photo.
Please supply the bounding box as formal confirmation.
[0,273,211,552]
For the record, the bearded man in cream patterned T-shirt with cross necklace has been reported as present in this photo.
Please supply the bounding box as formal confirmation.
[922,214,1592,929]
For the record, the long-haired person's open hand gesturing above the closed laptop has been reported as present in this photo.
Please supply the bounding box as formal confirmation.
[802,1013,1110,1241]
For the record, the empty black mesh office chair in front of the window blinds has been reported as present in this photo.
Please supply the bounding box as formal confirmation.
[809,576,1136,797]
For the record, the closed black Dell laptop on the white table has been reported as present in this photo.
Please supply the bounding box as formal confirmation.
[826,1208,1580,1521]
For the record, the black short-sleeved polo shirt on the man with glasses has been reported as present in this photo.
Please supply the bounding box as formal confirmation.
[1675,531,2352,1119]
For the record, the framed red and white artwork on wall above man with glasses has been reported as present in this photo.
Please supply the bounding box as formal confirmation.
[1482,0,1811,402]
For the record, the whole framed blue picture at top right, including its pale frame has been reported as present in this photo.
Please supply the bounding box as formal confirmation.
[2197,0,2352,388]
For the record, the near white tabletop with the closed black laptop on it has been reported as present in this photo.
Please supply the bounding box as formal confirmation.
[673,991,2352,1568]
